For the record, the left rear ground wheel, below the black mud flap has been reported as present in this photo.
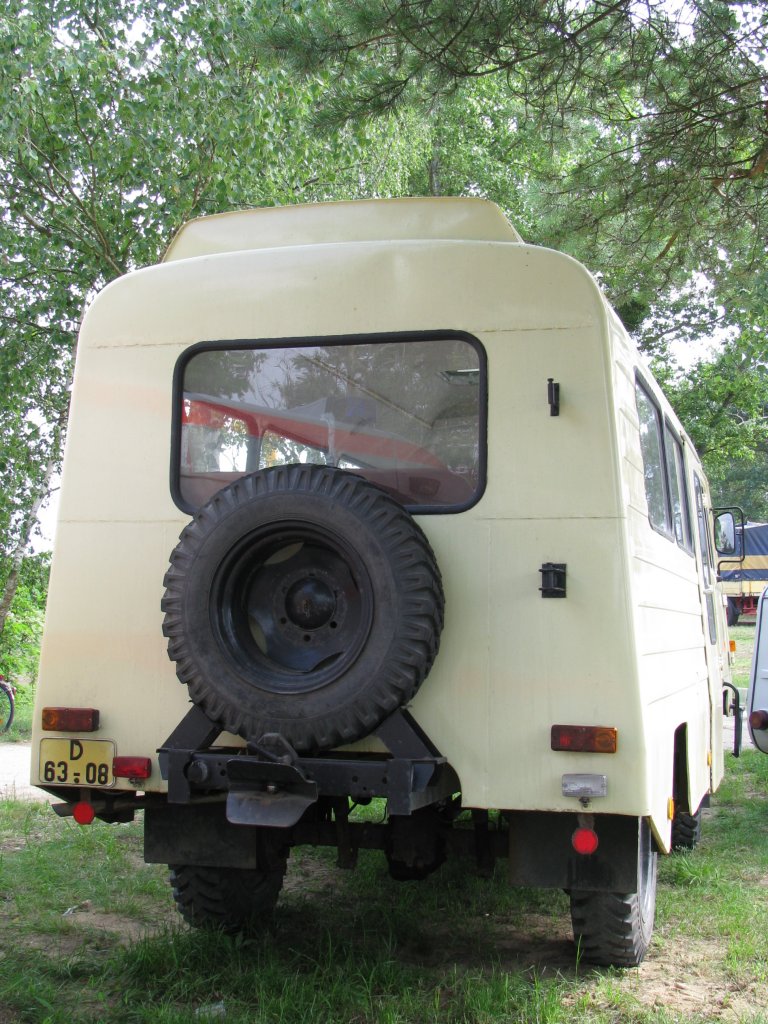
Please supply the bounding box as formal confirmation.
[170,864,285,935]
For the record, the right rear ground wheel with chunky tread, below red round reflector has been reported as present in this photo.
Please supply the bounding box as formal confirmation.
[570,820,657,967]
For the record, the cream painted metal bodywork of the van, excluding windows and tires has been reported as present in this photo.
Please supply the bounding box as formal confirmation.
[33,200,728,848]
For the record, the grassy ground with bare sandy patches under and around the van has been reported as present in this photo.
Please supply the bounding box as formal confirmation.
[0,627,768,1024]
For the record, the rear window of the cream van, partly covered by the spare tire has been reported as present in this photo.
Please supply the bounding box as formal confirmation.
[173,335,485,511]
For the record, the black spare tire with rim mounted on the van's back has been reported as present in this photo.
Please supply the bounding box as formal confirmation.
[162,465,443,752]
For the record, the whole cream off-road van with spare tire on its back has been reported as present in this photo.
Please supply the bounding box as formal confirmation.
[33,199,729,966]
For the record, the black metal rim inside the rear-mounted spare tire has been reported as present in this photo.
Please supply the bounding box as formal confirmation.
[209,522,374,693]
